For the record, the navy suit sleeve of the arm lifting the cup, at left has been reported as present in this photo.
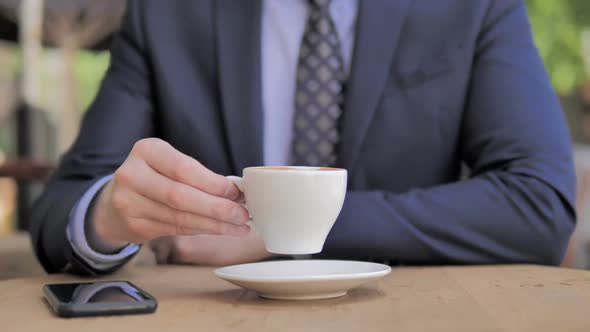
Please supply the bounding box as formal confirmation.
[30,1,154,275]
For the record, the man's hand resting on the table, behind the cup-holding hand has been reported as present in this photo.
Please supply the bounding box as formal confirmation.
[150,230,271,266]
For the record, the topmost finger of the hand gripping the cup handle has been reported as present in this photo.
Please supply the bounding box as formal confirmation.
[132,138,240,200]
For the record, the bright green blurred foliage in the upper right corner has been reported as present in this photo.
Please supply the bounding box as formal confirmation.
[526,0,590,94]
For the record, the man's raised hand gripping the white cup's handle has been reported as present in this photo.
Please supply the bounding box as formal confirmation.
[89,138,250,248]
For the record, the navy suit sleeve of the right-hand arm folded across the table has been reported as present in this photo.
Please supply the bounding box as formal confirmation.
[322,1,575,264]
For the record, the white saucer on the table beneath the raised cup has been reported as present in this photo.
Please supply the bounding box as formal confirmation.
[215,260,391,300]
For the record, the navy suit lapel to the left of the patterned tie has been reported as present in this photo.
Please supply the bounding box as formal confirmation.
[215,0,263,174]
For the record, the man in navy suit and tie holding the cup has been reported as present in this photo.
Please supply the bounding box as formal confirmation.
[31,0,575,274]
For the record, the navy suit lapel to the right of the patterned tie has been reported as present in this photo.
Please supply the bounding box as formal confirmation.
[340,0,412,169]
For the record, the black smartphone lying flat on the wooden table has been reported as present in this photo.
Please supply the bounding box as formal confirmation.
[43,281,158,317]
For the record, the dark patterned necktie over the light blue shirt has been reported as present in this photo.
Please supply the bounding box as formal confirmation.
[291,0,346,166]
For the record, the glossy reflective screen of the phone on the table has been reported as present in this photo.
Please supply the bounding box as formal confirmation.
[48,281,147,304]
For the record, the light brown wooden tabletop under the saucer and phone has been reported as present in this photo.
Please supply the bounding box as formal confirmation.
[0,266,590,332]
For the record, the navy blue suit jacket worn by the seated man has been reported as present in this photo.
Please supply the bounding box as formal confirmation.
[31,0,575,273]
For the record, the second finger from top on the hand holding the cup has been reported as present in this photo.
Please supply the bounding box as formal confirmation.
[114,160,249,224]
